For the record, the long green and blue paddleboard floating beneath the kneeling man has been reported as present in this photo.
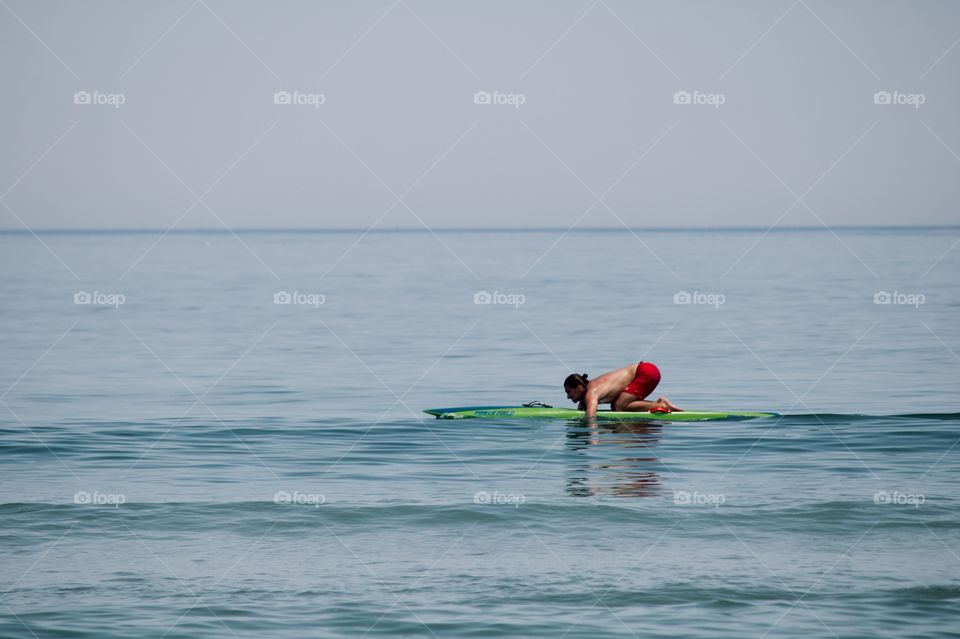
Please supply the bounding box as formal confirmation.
[423,406,777,422]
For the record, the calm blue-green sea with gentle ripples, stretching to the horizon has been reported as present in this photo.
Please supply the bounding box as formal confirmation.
[0,228,960,639]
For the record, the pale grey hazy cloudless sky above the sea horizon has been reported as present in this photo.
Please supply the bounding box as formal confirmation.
[0,0,960,229]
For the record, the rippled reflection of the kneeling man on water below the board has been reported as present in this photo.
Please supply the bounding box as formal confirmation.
[566,421,663,497]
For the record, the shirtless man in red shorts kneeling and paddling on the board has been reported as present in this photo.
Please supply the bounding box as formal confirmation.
[563,362,683,417]
